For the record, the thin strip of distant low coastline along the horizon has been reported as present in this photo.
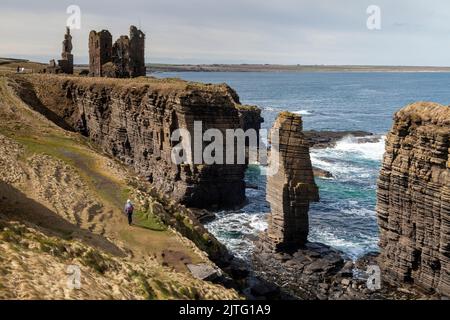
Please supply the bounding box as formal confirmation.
[147,64,450,72]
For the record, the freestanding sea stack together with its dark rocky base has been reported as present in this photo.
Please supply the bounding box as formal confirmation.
[253,112,353,299]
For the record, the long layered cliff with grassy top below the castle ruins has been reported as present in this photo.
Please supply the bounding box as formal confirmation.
[17,75,261,207]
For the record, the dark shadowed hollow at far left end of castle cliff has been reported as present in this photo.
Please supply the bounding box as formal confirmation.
[9,76,75,131]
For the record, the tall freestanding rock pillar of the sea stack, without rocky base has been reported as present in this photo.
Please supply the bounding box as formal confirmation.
[265,112,319,251]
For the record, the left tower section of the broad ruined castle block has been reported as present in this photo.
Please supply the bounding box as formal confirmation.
[89,30,112,77]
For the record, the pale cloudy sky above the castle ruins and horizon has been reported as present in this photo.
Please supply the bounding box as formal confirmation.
[0,0,450,66]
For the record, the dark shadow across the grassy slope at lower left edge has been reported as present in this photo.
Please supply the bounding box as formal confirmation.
[0,181,125,257]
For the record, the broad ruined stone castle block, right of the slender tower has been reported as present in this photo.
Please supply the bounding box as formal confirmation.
[89,26,146,78]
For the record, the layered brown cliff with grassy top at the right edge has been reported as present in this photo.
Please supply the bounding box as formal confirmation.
[377,103,450,296]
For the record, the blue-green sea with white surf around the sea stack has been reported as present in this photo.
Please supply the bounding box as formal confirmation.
[152,72,450,261]
